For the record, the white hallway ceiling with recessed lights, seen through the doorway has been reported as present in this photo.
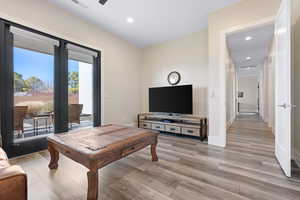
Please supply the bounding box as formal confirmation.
[227,25,274,75]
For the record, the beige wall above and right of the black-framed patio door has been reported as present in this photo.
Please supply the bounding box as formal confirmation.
[0,0,141,124]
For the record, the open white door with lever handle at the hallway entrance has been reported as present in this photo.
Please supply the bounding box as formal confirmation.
[275,0,292,177]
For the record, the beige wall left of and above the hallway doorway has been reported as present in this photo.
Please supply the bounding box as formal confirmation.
[208,0,280,146]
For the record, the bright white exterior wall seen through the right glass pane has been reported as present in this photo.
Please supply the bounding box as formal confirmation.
[79,62,93,114]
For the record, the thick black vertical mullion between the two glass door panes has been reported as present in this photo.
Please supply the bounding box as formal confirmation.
[54,41,68,133]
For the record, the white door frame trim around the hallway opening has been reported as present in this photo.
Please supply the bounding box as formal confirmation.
[212,16,276,147]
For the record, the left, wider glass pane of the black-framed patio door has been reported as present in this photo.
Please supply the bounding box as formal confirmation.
[11,28,58,142]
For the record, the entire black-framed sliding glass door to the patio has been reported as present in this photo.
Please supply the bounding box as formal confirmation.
[0,19,101,157]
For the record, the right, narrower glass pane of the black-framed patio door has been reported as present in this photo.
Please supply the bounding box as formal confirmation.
[67,45,97,130]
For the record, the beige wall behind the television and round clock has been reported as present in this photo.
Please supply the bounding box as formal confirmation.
[141,30,208,116]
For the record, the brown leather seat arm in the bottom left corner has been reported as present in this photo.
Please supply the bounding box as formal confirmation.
[0,166,27,200]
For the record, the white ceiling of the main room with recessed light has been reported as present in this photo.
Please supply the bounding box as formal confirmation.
[48,0,240,47]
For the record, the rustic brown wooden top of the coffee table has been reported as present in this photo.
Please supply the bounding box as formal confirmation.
[48,124,157,155]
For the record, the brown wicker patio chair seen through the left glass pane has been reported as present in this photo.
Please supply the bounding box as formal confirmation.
[14,106,28,134]
